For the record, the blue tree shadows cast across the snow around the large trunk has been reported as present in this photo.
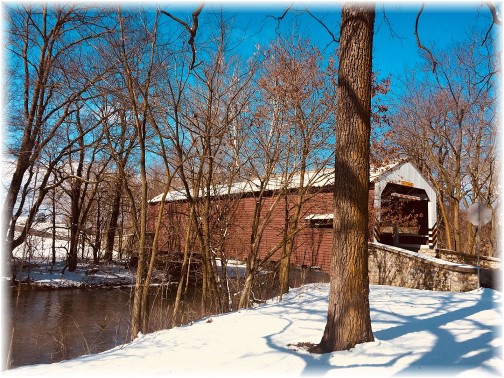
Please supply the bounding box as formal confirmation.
[265,289,501,376]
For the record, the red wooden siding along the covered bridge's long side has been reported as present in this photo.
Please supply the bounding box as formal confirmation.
[149,191,334,272]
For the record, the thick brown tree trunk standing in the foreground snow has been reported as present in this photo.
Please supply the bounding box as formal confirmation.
[312,3,375,353]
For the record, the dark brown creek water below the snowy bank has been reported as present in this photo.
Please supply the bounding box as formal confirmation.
[5,270,328,368]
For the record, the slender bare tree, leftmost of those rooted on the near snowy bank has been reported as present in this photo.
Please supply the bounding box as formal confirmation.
[104,7,159,339]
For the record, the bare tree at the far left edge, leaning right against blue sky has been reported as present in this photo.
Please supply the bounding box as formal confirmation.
[3,5,112,255]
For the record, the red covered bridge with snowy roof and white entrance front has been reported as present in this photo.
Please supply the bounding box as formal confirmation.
[149,162,437,272]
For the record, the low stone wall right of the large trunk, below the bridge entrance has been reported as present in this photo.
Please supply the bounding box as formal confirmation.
[369,243,478,292]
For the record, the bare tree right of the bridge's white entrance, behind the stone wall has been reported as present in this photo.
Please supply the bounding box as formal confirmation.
[390,36,498,252]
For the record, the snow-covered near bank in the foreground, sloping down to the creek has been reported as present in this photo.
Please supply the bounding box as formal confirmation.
[3,284,504,377]
